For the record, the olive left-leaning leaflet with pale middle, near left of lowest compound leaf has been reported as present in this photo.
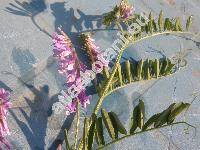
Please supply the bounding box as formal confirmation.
[101,109,115,139]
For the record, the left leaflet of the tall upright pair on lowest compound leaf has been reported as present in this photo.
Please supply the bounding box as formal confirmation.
[130,106,139,134]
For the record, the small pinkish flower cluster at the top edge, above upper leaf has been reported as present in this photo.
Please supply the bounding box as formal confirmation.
[119,0,134,19]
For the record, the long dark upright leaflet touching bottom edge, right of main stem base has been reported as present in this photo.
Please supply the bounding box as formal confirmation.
[88,114,97,150]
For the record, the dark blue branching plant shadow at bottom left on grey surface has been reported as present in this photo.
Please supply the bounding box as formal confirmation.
[10,83,73,150]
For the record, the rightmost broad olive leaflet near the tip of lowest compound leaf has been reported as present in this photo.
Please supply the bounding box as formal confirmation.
[168,102,190,123]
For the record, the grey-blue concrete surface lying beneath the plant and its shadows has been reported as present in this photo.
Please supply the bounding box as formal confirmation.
[0,0,200,150]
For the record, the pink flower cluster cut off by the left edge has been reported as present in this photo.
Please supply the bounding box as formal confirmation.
[0,88,11,149]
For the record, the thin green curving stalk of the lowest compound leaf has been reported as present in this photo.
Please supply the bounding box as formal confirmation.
[98,121,196,150]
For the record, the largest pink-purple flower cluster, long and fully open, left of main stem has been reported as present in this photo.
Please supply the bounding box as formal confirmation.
[53,30,90,115]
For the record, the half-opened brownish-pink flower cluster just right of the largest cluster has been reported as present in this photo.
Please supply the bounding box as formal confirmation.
[81,34,109,67]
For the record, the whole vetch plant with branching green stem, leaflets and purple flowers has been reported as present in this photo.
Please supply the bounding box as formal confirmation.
[51,0,193,150]
